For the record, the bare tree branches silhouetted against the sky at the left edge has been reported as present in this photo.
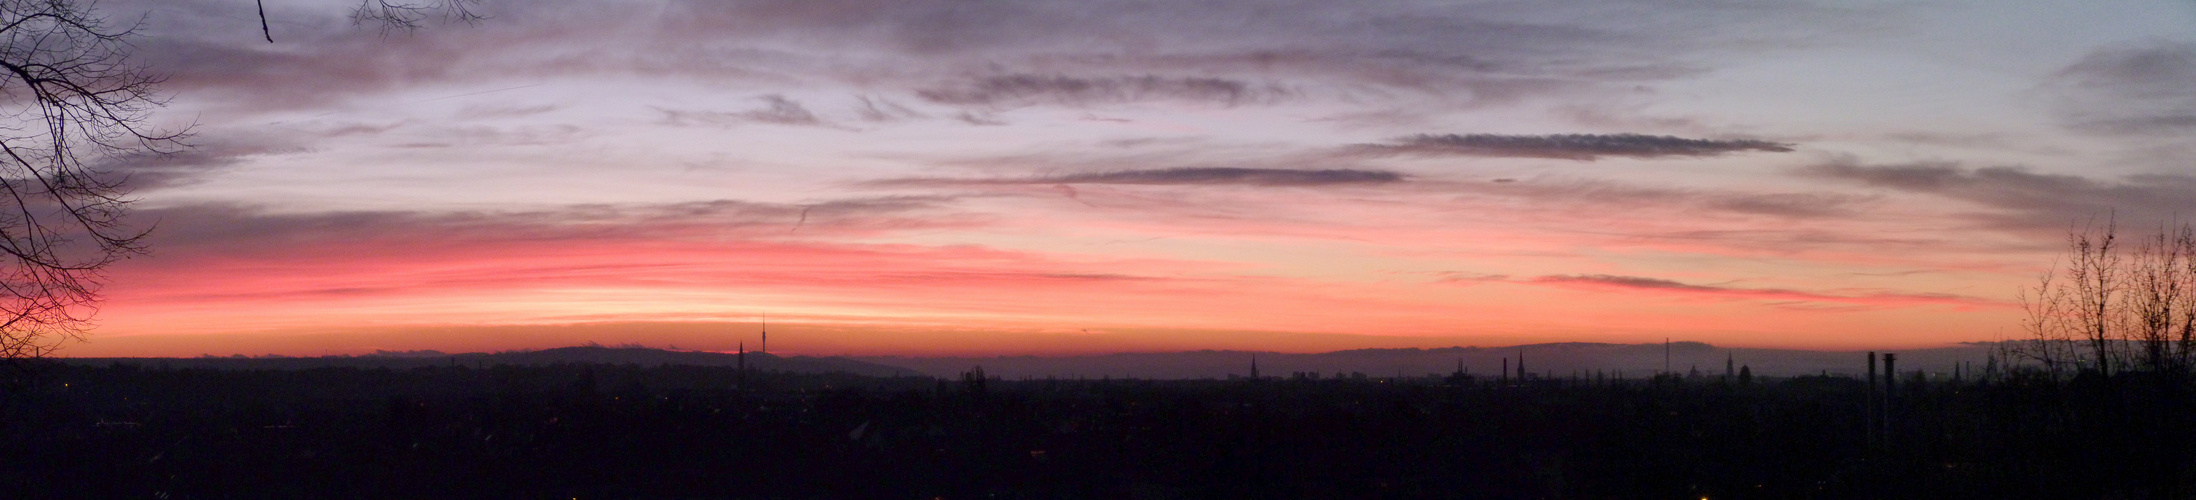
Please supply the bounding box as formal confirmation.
[0,0,184,366]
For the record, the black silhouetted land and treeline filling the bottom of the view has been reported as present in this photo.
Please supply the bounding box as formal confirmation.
[0,364,2196,498]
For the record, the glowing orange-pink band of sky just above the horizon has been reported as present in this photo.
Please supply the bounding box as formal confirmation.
[68,222,2012,355]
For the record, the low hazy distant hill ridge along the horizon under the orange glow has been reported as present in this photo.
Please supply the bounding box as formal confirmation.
[59,342,1990,379]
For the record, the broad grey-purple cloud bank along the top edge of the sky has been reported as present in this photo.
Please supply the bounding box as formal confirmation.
[116,0,1867,110]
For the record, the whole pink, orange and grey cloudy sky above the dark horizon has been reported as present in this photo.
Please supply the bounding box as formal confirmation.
[64,0,2196,355]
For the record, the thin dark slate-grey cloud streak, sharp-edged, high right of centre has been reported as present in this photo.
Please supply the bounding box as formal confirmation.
[1353,134,1792,162]
